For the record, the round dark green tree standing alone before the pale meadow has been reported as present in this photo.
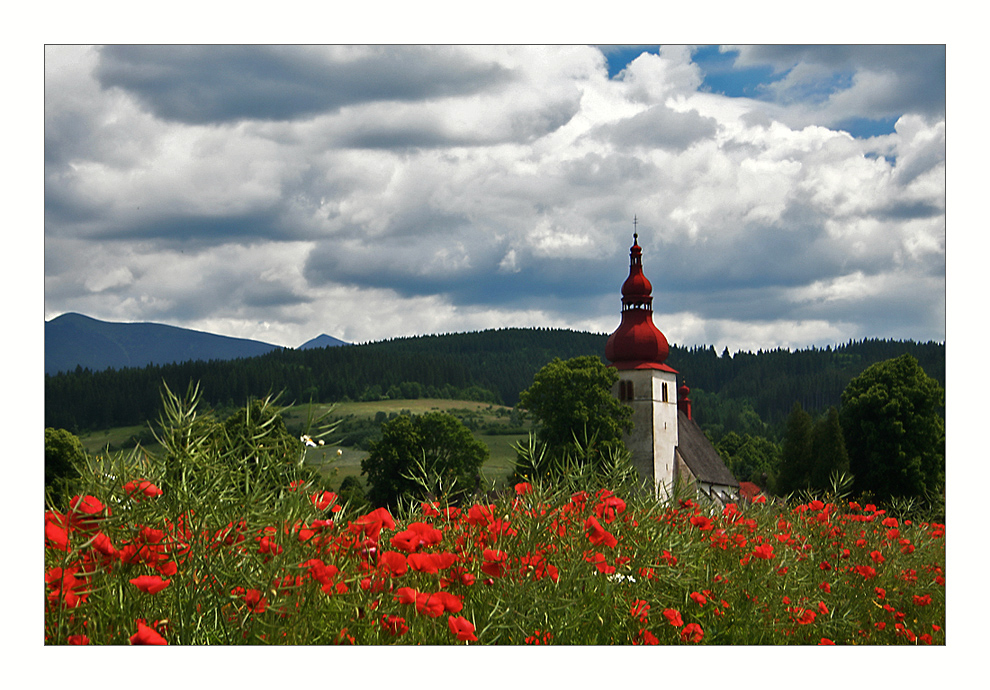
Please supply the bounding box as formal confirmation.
[361,412,488,509]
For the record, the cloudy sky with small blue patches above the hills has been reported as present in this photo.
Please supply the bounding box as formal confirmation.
[44,44,946,352]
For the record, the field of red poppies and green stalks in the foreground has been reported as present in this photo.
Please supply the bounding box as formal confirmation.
[44,448,946,646]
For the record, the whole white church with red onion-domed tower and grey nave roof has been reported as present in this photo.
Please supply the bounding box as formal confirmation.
[605,228,739,504]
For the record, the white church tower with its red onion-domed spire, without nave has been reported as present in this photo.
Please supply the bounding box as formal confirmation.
[605,233,678,496]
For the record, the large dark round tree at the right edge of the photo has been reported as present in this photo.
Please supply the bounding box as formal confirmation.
[839,354,945,500]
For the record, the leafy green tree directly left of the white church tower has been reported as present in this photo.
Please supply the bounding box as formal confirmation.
[519,356,632,472]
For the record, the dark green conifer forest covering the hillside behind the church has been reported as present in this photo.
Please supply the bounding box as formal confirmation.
[45,328,945,439]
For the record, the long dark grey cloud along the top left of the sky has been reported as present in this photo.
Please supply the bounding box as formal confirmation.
[96,45,512,124]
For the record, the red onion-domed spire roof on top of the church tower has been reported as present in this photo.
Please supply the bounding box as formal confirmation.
[605,234,676,373]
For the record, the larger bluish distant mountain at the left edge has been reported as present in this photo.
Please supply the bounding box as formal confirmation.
[45,313,282,374]
